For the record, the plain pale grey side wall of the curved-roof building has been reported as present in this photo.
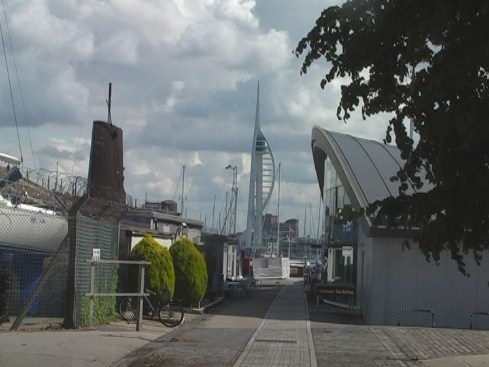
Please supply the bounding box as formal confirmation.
[357,229,489,328]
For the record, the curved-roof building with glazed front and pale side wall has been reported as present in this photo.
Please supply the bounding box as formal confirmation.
[311,127,489,328]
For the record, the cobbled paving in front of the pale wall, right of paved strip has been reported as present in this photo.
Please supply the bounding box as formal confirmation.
[312,322,489,367]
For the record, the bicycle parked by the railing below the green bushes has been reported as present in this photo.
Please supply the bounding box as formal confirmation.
[119,289,184,327]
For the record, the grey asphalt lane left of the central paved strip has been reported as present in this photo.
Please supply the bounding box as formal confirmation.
[113,280,290,367]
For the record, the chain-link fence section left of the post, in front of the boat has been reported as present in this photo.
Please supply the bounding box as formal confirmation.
[0,167,80,330]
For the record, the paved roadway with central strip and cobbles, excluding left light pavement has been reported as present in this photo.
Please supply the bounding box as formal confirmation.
[114,279,489,367]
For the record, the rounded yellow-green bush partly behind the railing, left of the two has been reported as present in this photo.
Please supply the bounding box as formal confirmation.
[129,233,175,297]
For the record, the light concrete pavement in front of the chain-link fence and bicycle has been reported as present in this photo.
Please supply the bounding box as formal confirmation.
[0,321,170,367]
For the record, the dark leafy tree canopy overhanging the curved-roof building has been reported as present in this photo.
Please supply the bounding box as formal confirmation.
[295,0,489,272]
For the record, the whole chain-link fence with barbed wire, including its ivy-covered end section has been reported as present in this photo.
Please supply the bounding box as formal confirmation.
[0,167,127,330]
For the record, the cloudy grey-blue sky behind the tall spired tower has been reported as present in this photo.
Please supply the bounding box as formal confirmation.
[0,0,386,237]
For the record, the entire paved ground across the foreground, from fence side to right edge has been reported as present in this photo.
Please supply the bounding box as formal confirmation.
[0,279,489,367]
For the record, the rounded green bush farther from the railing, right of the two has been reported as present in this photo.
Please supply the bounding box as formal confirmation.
[170,237,207,306]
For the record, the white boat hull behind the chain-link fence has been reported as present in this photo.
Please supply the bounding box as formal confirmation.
[0,153,68,253]
